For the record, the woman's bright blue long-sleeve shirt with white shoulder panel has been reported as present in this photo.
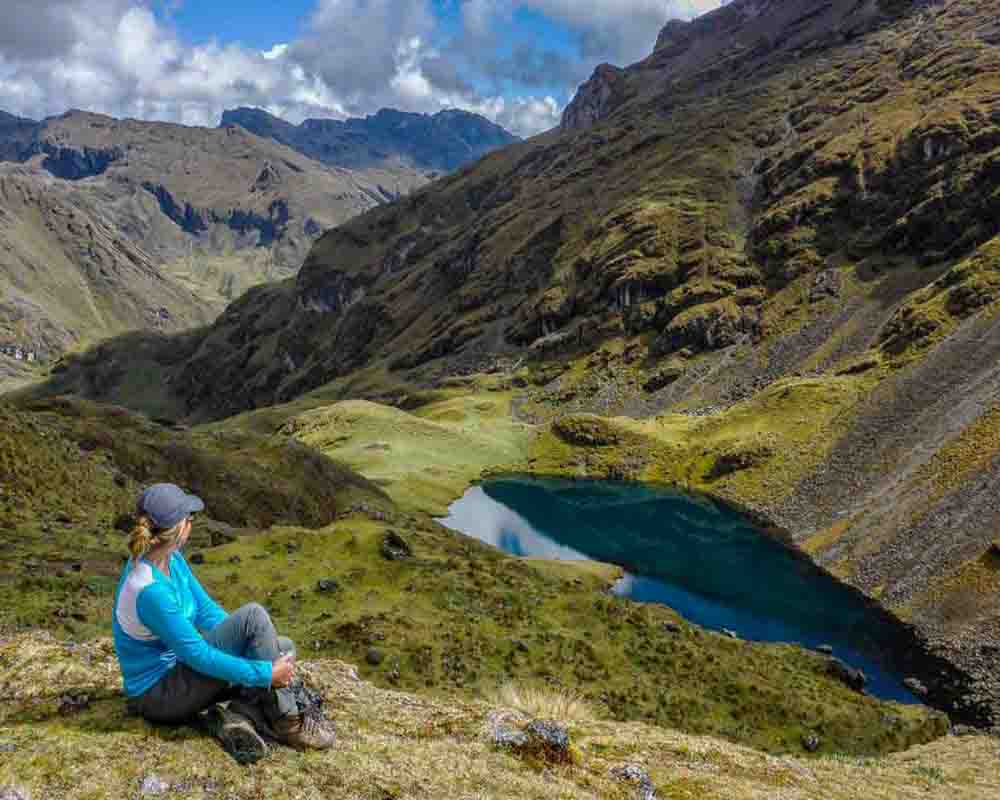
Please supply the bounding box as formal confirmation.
[112,552,271,697]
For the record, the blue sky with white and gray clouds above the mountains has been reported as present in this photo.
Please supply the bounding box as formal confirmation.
[0,0,720,135]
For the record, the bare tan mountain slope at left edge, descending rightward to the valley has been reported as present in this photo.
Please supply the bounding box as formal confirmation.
[0,165,215,359]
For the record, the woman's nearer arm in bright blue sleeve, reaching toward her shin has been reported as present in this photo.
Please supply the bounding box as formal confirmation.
[136,583,272,687]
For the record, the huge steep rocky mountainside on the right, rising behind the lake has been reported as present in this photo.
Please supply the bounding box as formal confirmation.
[31,0,1000,725]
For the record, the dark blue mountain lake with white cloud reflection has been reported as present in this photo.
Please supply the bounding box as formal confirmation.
[441,477,917,703]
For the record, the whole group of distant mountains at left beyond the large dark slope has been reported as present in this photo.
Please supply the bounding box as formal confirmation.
[0,104,511,357]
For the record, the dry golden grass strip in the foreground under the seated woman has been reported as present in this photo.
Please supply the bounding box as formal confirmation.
[0,634,1000,800]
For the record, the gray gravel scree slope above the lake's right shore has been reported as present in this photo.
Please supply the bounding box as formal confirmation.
[768,317,1000,723]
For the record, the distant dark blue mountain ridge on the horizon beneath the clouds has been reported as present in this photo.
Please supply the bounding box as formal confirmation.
[222,108,518,172]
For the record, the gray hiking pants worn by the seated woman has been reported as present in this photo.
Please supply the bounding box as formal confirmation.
[129,603,297,723]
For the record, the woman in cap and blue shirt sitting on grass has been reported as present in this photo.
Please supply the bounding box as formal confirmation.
[113,483,333,760]
